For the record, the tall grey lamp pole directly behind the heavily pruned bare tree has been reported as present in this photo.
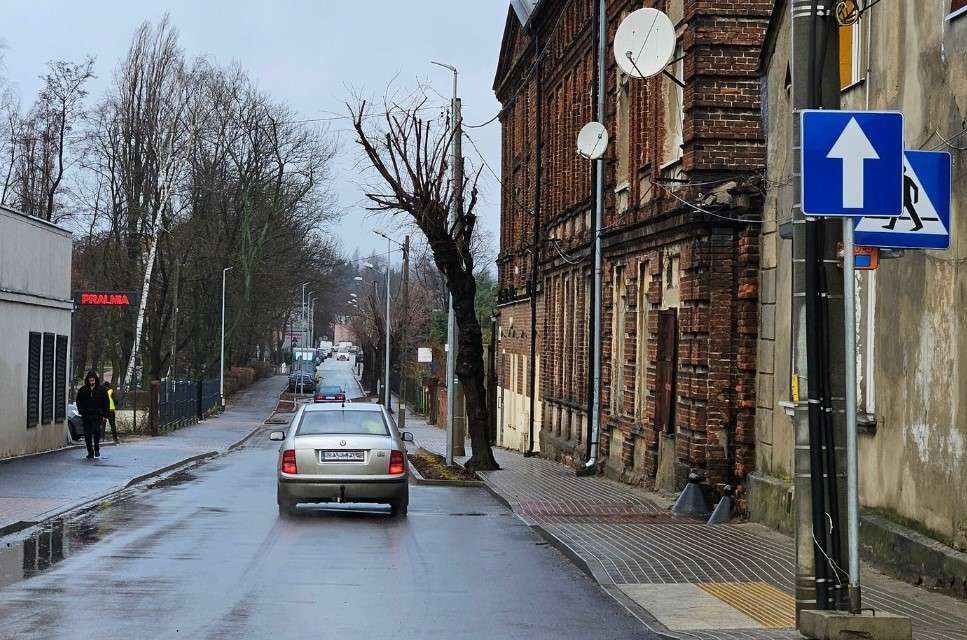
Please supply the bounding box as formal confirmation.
[433,62,466,465]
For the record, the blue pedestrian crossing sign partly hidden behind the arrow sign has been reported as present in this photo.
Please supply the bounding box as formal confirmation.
[853,151,950,249]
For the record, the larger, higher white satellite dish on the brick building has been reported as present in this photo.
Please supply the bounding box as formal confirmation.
[614,9,675,78]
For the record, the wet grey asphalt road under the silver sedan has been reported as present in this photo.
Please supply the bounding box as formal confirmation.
[0,362,647,640]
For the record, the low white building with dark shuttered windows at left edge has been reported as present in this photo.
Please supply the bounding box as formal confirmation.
[0,206,73,458]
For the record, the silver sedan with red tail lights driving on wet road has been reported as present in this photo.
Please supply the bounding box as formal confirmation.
[269,403,413,516]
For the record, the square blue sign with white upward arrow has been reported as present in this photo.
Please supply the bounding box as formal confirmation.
[801,110,903,217]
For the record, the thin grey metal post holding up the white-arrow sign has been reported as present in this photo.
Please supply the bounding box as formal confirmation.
[843,218,860,613]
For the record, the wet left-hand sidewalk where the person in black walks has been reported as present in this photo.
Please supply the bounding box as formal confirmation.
[0,376,285,535]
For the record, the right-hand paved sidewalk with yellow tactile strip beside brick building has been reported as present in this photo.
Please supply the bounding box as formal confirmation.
[398,402,967,640]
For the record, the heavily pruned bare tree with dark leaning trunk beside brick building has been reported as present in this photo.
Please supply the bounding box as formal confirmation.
[349,100,499,470]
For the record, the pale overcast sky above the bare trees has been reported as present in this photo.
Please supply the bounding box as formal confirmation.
[0,0,508,264]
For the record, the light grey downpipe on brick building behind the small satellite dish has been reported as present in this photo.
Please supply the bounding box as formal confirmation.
[577,0,608,476]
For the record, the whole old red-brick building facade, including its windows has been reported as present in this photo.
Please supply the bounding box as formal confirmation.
[495,0,771,500]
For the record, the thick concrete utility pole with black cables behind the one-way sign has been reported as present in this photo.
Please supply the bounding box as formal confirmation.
[789,0,859,624]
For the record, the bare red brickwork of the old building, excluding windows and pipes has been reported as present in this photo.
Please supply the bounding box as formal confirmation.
[496,0,771,498]
